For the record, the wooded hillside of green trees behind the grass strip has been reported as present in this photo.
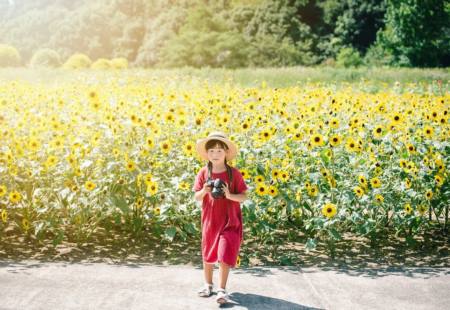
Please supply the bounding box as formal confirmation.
[0,0,450,68]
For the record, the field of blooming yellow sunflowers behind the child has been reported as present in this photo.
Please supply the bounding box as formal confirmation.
[0,71,450,260]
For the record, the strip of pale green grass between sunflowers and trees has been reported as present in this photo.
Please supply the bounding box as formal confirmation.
[0,67,450,91]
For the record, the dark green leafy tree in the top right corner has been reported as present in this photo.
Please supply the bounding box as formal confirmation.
[377,0,450,66]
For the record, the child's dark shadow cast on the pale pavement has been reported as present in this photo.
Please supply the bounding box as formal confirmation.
[220,292,319,310]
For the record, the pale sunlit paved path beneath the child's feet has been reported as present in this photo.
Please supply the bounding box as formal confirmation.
[0,261,450,310]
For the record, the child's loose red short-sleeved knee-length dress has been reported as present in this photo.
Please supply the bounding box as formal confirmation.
[193,166,247,267]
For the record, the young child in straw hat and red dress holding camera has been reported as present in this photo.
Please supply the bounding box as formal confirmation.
[193,132,247,304]
